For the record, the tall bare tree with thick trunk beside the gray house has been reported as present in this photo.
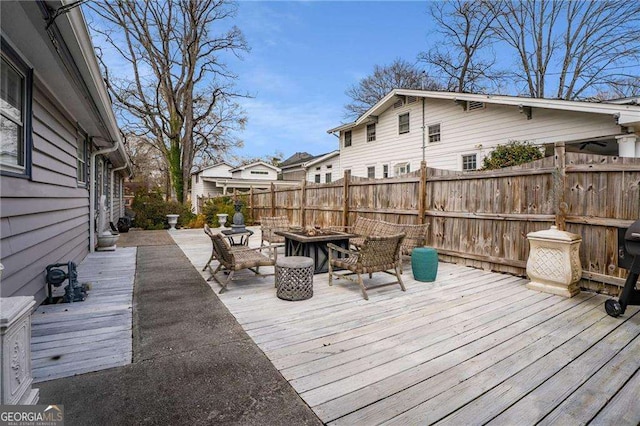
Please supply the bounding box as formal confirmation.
[89,0,248,201]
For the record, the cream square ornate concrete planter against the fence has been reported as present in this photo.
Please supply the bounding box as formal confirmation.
[527,226,582,297]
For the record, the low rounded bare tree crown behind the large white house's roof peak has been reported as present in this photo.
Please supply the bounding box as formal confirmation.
[344,58,442,118]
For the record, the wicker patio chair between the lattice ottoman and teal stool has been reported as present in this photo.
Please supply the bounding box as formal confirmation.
[327,234,406,300]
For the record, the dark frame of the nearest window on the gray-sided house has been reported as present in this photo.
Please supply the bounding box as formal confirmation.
[0,35,33,179]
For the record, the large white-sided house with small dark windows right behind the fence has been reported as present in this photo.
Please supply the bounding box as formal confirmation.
[328,89,640,178]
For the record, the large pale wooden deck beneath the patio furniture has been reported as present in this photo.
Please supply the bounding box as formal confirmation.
[173,230,640,425]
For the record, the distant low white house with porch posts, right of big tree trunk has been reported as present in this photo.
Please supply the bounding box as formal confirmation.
[191,161,296,213]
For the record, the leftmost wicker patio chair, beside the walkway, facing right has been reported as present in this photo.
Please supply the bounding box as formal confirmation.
[206,234,278,294]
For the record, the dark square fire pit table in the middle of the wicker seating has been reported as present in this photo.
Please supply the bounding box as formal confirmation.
[275,229,356,274]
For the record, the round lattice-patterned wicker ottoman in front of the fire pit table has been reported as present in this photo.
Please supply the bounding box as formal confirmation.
[276,256,313,300]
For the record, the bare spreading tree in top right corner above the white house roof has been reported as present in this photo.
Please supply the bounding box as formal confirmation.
[498,0,640,100]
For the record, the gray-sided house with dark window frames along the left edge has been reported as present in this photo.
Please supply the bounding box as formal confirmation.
[0,1,131,303]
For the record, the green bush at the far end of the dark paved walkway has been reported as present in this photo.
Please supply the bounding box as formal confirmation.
[132,189,195,229]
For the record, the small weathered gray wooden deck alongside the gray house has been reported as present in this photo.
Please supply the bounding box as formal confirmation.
[31,247,136,382]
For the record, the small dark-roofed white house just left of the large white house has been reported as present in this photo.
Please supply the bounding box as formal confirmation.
[279,150,341,183]
